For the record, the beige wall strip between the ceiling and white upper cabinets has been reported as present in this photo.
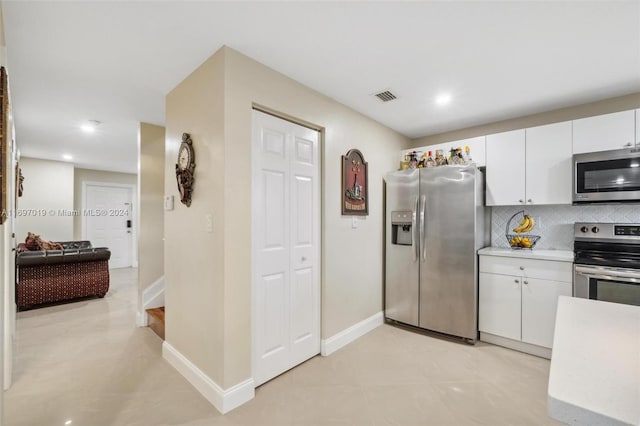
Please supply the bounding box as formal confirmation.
[405,93,640,148]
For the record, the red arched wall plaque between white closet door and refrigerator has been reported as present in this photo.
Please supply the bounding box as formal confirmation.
[342,149,369,216]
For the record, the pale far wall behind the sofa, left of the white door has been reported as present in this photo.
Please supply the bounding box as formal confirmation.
[16,157,74,242]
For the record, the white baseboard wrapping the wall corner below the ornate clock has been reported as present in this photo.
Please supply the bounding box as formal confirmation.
[162,340,255,414]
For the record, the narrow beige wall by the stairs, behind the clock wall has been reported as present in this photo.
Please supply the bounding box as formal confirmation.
[138,123,164,311]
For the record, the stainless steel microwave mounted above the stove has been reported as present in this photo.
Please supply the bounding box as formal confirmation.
[573,148,640,204]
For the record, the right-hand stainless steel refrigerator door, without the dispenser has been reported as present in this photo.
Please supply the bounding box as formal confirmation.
[420,166,482,340]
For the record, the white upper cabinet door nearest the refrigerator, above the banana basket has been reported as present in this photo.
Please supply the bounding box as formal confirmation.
[486,129,528,206]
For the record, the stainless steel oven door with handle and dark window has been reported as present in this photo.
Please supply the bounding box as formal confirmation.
[573,265,640,306]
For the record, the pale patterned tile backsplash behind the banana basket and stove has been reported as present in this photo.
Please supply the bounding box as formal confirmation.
[491,204,640,250]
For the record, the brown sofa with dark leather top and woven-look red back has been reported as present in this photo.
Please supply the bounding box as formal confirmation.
[16,241,111,310]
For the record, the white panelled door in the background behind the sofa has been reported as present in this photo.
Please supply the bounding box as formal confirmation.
[83,184,133,268]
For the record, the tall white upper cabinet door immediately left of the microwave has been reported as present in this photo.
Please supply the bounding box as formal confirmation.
[525,121,572,204]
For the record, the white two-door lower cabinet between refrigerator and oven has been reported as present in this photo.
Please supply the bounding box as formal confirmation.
[478,256,573,357]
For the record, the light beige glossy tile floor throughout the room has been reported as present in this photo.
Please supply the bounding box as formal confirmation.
[4,269,557,426]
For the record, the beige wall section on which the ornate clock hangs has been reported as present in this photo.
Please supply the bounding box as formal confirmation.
[164,51,228,385]
